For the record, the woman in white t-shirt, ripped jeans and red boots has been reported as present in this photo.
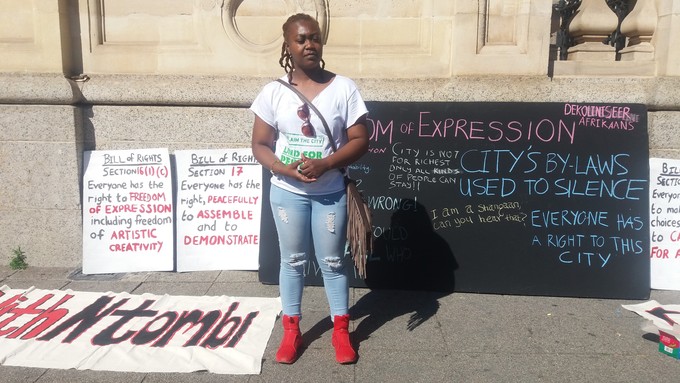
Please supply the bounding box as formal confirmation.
[250,14,368,364]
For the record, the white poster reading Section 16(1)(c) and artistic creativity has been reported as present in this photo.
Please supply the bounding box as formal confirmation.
[83,149,174,274]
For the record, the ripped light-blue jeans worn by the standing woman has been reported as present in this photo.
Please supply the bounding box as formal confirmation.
[269,185,349,318]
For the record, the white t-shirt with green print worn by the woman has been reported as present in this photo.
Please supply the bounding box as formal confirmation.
[250,74,368,195]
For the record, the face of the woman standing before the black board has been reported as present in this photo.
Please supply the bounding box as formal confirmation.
[286,20,323,70]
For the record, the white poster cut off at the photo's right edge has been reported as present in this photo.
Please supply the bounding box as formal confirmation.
[649,158,680,290]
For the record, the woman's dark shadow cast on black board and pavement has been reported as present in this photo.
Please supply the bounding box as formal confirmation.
[350,200,458,345]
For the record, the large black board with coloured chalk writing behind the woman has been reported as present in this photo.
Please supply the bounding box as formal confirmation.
[260,102,650,299]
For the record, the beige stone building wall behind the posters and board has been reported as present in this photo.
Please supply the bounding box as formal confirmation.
[0,0,680,266]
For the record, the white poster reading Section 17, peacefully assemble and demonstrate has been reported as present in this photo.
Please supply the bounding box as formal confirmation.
[175,148,262,271]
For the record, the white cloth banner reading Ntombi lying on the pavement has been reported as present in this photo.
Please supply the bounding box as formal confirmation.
[0,286,281,374]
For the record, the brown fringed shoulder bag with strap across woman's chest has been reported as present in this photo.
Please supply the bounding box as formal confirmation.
[276,79,373,279]
